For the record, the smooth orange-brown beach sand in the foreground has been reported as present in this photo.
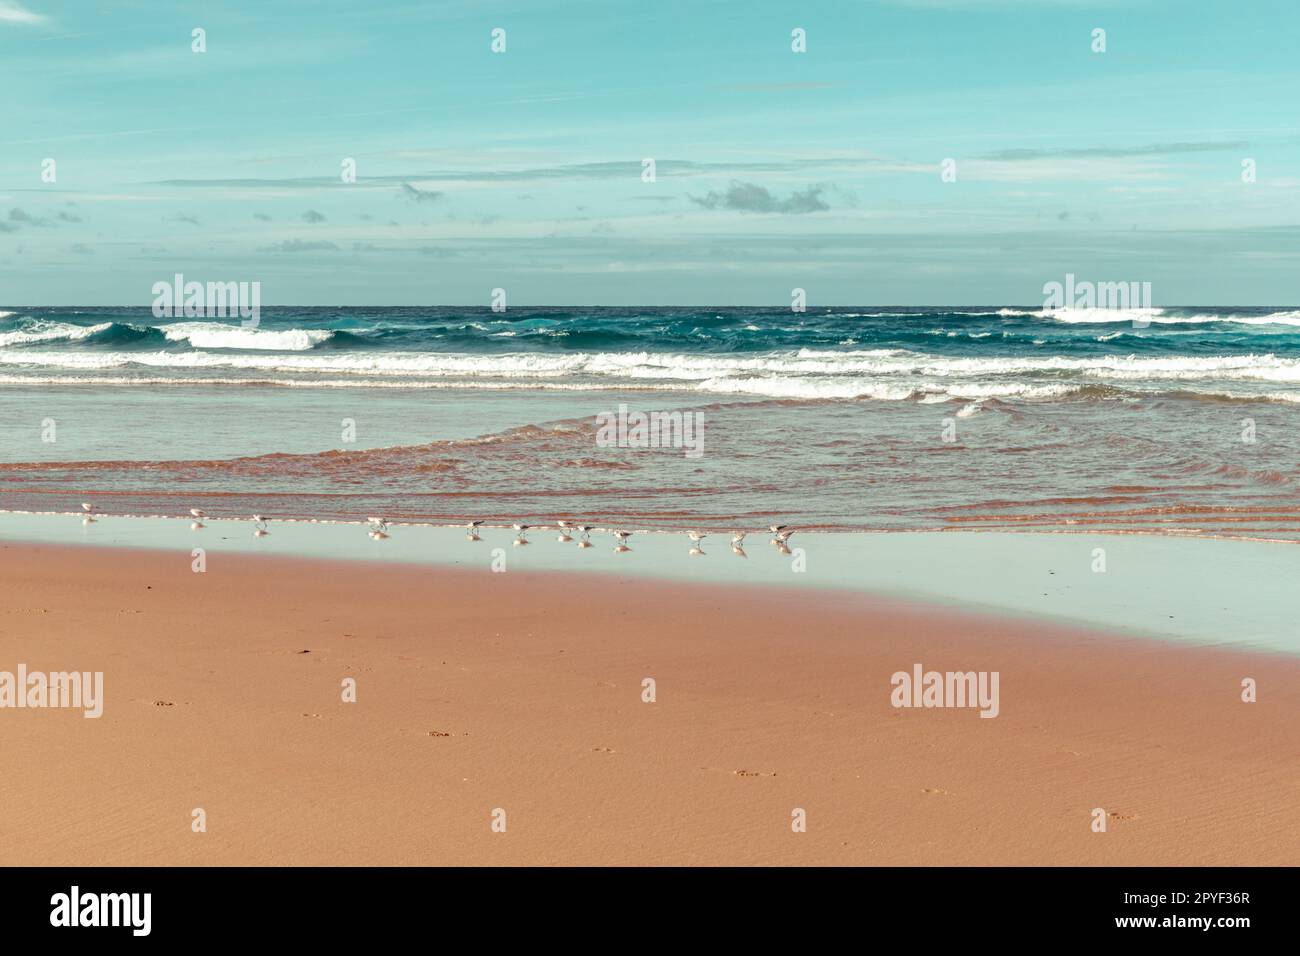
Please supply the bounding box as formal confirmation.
[0,544,1300,865]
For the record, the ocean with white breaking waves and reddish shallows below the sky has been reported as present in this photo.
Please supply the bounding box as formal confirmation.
[0,306,1300,541]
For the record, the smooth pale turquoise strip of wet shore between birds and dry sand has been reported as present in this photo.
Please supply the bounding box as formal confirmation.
[0,514,1300,653]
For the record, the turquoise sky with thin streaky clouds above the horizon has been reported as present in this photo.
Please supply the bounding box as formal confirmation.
[0,0,1300,307]
